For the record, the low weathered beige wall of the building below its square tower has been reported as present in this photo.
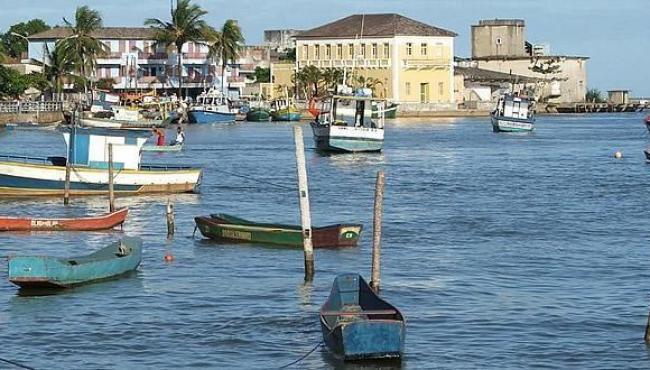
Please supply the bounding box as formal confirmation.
[476,57,587,103]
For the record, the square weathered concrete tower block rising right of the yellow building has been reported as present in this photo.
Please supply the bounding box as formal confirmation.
[471,20,526,58]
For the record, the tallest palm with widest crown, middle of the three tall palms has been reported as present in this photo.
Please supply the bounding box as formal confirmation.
[144,0,215,99]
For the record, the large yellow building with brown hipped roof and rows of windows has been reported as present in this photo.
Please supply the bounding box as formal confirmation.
[274,14,456,104]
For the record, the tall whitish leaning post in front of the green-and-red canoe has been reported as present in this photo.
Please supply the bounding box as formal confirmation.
[293,126,314,281]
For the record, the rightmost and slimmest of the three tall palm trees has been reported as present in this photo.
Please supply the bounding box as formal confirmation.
[208,19,244,94]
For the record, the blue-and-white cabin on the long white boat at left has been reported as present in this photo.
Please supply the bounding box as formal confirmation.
[62,127,151,170]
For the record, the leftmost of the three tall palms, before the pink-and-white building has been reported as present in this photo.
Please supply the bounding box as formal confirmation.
[60,5,109,98]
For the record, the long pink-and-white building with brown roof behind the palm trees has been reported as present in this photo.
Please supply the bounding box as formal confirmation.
[28,27,242,95]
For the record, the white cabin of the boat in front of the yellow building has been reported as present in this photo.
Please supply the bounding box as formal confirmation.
[321,95,385,129]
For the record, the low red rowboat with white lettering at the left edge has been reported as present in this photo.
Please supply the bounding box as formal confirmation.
[0,208,129,231]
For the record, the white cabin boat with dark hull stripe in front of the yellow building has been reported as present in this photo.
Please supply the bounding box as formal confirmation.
[310,95,385,152]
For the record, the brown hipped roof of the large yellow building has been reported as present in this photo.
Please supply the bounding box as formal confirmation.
[297,13,457,39]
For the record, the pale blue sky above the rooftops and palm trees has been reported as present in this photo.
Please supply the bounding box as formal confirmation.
[0,0,650,97]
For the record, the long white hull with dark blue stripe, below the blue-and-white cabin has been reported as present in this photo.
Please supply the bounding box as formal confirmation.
[0,162,202,197]
